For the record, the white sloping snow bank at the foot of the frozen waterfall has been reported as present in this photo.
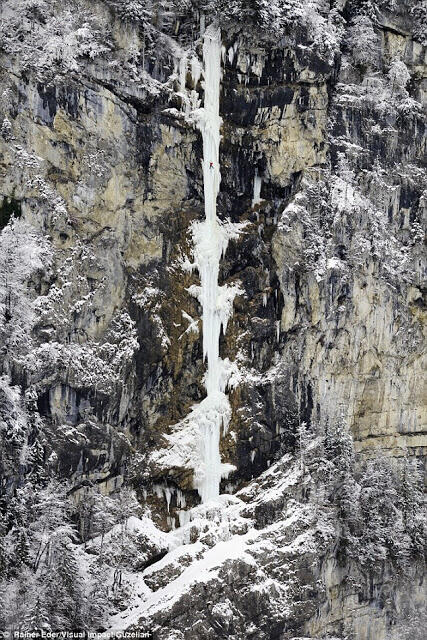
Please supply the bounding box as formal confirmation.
[103,457,332,632]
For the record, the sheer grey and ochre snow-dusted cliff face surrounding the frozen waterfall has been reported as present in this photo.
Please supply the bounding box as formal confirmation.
[0,0,427,640]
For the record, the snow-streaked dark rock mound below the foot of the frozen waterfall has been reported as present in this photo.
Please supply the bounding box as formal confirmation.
[108,455,334,638]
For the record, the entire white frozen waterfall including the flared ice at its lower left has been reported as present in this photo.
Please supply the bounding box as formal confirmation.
[152,26,245,504]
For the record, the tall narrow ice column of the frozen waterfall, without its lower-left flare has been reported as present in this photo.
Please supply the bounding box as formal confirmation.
[193,26,238,502]
